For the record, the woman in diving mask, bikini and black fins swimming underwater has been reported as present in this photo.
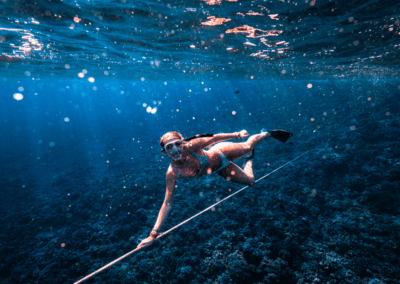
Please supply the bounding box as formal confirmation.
[138,129,292,247]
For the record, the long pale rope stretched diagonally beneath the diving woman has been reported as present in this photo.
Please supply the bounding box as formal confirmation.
[74,152,307,284]
